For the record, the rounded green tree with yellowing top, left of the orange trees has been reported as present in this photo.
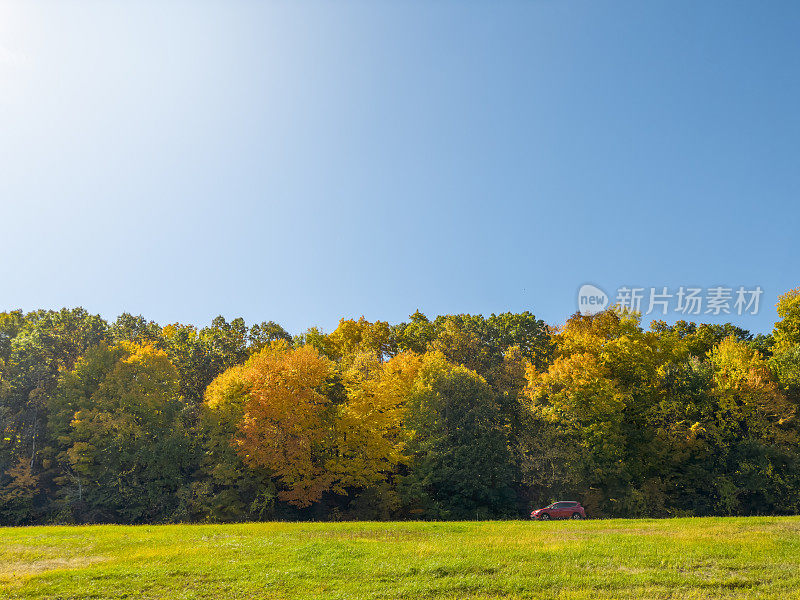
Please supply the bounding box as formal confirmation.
[50,342,193,523]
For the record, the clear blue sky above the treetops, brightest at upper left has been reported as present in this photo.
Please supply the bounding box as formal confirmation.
[0,0,800,332]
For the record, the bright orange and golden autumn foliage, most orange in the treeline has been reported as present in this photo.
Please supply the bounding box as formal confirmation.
[205,341,419,508]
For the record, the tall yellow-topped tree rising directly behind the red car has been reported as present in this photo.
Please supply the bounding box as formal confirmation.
[523,310,664,514]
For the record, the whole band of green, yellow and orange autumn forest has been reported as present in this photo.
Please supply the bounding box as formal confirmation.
[0,288,800,525]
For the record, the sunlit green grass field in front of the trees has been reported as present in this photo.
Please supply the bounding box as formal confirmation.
[0,517,800,599]
